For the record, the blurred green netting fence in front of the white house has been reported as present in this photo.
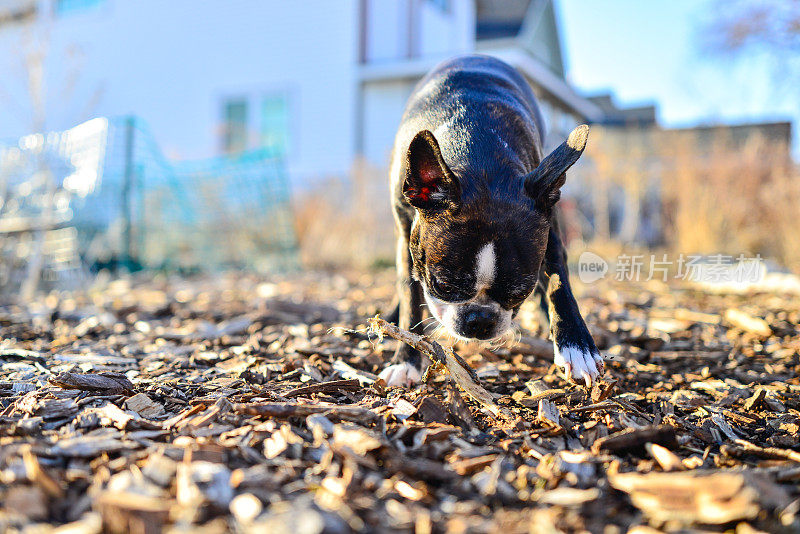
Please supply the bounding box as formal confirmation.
[0,117,298,296]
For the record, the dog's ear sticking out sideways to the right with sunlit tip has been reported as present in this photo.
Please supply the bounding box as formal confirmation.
[525,124,589,210]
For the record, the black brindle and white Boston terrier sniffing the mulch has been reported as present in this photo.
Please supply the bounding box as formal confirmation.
[380,55,603,386]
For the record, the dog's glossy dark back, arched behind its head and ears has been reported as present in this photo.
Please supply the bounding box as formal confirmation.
[390,55,544,209]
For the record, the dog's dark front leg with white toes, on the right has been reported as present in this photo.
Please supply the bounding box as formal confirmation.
[541,227,603,386]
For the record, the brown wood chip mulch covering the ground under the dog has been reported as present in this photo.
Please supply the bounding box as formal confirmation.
[0,273,800,534]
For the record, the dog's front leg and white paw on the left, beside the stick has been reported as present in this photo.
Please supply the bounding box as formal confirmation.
[380,232,427,386]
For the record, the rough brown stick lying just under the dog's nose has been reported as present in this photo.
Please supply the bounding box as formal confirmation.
[369,317,501,417]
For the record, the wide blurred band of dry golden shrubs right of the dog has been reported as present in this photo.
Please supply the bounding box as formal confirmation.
[576,127,800,272]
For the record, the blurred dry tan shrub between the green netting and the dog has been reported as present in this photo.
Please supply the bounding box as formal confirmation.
[295,161,395,269]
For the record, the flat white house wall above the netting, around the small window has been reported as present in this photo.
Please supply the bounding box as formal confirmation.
[0,0,358,186]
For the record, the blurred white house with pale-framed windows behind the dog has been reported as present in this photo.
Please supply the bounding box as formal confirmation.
[0,0,603,184]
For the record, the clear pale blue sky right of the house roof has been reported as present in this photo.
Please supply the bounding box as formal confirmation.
[558,0,800,132]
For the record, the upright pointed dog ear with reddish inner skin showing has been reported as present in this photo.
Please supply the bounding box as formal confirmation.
[403,130,461,210]
